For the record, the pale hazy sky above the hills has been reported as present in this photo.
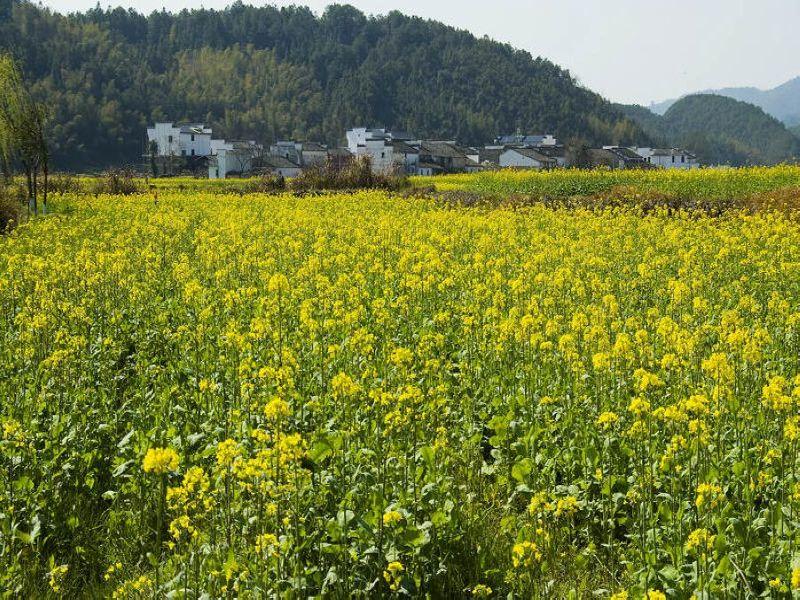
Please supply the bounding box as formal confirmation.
[43,0,800,104]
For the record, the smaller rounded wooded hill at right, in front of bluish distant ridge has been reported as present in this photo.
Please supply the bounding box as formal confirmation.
[618,94,800,165]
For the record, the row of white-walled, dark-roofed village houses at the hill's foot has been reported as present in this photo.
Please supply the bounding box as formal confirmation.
[145,123,700,179]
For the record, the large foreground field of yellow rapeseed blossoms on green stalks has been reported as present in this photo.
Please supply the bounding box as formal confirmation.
[0,173,800,600]
